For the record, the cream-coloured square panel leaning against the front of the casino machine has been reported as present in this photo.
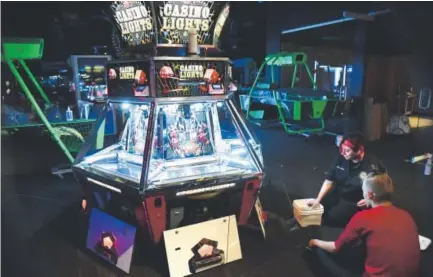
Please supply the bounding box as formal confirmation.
[164,215,242,277]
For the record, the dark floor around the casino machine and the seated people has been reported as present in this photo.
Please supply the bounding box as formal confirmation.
[1,119,433,277]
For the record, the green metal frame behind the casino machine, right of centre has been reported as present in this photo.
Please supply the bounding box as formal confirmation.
[246,52,335,135]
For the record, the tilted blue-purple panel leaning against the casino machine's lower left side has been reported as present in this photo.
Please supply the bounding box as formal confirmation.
[86,209,136,273]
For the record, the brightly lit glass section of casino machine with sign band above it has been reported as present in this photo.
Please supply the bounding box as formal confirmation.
[73,57,263,193]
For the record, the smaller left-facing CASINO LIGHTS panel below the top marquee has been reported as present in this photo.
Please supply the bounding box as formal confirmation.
[107,61,150,97]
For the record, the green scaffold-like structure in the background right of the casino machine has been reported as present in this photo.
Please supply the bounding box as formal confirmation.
[246,52,337,135]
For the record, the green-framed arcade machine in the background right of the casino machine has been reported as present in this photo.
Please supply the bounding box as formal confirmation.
[241,52,337,137]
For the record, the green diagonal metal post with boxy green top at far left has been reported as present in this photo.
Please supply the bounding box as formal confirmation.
[1,38,74,163]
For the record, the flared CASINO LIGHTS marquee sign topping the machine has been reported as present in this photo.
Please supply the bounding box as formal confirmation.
[112,1,230,46]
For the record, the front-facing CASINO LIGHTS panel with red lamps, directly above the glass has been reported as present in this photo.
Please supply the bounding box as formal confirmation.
[155,60,226,97]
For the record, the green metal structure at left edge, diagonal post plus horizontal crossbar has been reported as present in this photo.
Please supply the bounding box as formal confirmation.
[1,38,94,164]
